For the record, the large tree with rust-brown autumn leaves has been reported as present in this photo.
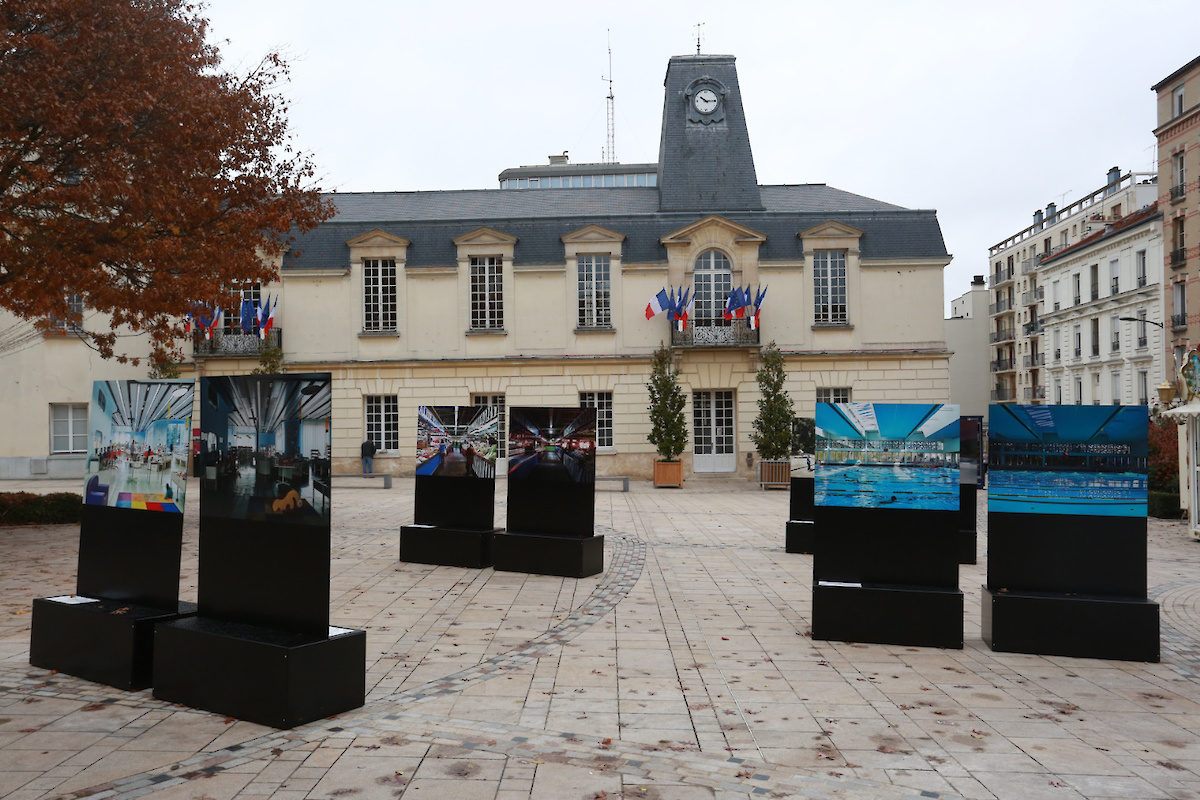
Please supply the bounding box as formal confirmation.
[0,0,331,361]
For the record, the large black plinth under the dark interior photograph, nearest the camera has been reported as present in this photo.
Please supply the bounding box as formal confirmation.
[154,616,366,728]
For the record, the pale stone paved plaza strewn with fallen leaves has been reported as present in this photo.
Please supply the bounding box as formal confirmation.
[0,480,1200,800]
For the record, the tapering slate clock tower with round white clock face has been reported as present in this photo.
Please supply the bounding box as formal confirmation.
[659,55,762,213]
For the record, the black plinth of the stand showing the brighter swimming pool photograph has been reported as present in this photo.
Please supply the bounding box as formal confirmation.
[812,583,962,649]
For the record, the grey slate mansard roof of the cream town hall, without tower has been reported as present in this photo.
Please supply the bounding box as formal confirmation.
[284,184,947,269]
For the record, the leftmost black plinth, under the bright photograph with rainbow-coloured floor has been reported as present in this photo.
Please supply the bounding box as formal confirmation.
[29,595,196,690]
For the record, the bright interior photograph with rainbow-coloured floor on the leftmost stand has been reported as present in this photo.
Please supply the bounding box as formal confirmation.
[83,380,196,513]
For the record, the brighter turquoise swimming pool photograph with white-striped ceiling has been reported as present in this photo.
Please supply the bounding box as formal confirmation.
[815,403,960,511]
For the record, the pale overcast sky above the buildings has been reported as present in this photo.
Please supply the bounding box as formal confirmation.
[206,0,1200,309]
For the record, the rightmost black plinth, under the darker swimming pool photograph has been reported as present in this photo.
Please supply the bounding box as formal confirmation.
[980,587,1159,662]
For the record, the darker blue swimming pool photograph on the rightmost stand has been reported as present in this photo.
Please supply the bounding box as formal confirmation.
[988,404,1150,517]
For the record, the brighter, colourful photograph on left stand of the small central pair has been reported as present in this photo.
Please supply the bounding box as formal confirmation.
[416,405,500,477]
